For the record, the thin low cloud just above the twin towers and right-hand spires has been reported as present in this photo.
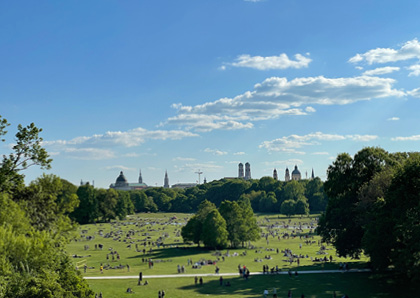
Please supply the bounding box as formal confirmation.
[259,132,377,154]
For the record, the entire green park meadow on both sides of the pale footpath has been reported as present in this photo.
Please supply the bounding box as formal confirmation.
[67,213,416,298]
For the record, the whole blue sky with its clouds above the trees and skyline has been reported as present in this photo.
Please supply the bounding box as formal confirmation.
[0,0,420,188]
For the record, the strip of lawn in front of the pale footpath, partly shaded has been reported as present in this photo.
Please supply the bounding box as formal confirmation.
[89,273,419,298]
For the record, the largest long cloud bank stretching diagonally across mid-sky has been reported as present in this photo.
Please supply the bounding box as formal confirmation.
[165,76,405,131]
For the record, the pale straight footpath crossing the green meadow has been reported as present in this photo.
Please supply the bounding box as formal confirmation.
[84,269,371,280]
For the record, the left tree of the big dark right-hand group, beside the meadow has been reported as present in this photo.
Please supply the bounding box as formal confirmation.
[318,147,401,257]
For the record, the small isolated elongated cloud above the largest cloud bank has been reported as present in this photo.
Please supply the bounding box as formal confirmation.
[228,53,312,70]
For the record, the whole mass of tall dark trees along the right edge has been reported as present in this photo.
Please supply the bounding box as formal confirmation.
[318,147,420,280]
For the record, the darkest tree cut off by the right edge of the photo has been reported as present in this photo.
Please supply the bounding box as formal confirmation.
[378,153,420,281]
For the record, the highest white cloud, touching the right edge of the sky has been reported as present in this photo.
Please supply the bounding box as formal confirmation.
[349,39,420,65]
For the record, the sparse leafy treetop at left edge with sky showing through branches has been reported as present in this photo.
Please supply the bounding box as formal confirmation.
[0,116,52,193]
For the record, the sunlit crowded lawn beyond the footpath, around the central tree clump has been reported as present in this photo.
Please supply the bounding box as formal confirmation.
[67,213,366,276]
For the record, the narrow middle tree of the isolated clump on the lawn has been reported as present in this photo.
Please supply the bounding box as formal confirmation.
[201,209,228,248]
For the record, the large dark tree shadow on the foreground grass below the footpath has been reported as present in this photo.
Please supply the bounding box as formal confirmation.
[178,273,419,298]
